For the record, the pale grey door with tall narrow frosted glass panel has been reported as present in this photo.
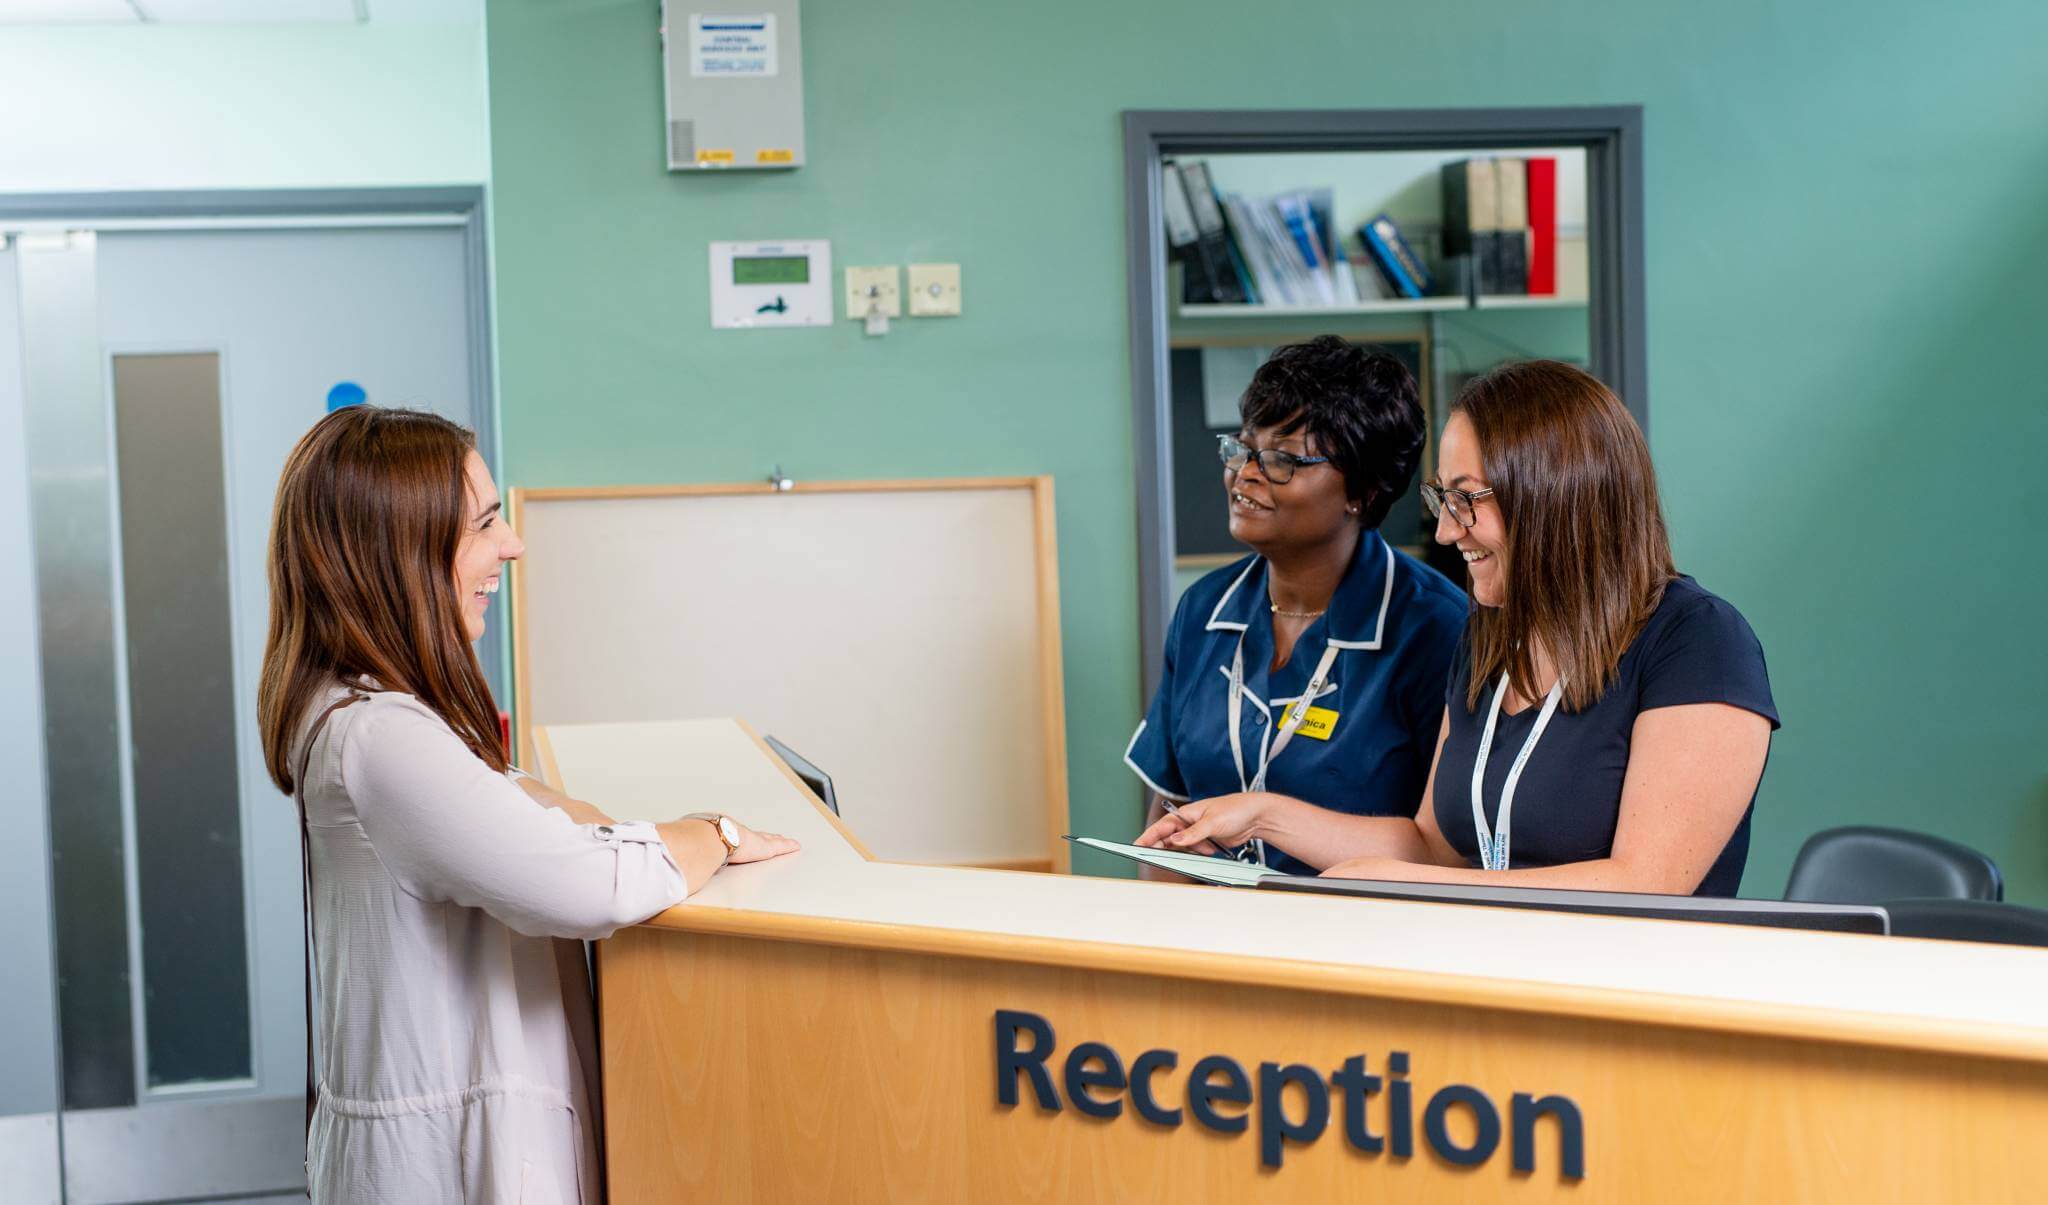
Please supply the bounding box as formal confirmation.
[0,225,498,1201]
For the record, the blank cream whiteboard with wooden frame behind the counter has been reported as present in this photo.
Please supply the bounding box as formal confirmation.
[508,477,1067,869]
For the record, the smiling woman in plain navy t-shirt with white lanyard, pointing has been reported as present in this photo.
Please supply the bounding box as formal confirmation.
[1143,361,1778,896]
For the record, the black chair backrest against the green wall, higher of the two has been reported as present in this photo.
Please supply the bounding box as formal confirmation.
[1786,824,2005,904]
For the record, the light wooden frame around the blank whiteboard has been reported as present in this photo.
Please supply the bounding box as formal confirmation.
[506,475,1071,873]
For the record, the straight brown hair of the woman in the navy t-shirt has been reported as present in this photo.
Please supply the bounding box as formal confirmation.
[1452,361,1677,711]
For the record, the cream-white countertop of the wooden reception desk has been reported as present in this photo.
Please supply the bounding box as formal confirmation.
[543,719,2048,1062]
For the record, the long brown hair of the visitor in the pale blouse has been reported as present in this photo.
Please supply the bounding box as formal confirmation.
[256,406,508,795]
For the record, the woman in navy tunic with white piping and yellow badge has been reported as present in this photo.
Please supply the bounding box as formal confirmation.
[1124,336,1466,873]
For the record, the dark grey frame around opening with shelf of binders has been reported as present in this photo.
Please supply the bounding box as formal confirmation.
[1124,105,1649,699]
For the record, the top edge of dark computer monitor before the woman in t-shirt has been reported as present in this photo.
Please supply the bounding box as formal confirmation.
[1257,875,1890,934]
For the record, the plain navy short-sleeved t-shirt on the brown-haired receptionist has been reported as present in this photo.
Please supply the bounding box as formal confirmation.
[1434,578,1778,896]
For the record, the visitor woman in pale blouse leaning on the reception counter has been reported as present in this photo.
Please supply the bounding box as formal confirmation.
[258,406,797,1203]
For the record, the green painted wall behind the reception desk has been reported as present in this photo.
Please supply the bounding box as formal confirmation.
[487,0,2048,904]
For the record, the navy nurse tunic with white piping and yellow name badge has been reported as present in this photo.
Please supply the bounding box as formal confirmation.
[1124,531,1468,875]
